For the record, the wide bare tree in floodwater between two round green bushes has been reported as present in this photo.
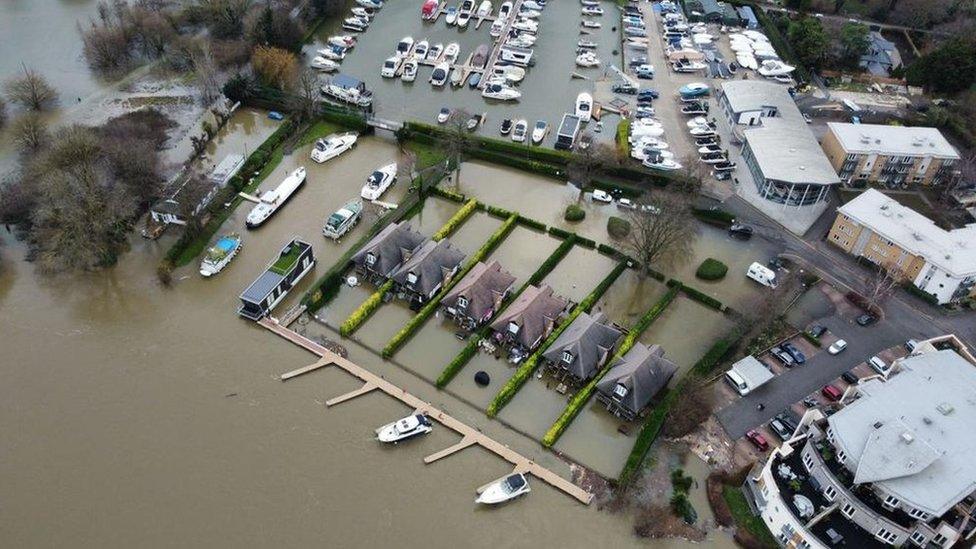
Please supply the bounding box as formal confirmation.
[626,192,698,276]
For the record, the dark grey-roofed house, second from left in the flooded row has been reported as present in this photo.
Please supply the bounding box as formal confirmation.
[391,239,464,301]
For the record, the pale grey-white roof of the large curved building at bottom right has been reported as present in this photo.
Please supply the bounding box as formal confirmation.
[828,350,976,516]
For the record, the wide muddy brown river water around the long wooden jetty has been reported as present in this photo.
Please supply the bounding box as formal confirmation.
[0,131,730,547]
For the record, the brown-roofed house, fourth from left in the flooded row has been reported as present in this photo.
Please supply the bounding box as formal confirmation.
[491,285,569,350]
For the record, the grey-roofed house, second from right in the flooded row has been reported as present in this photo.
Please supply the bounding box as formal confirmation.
[542,313,622,382]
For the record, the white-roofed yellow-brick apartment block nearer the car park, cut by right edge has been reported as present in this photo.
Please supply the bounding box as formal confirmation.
[827,189,976,304]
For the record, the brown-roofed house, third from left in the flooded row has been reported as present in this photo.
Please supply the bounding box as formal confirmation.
[441,261,515,327]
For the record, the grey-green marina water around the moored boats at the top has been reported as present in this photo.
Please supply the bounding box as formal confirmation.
[305,2,620,145]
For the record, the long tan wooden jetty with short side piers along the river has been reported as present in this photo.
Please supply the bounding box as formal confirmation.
[258,316,593,505]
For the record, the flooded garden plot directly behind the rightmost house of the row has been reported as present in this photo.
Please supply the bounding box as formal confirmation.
[640,294,733,383]
